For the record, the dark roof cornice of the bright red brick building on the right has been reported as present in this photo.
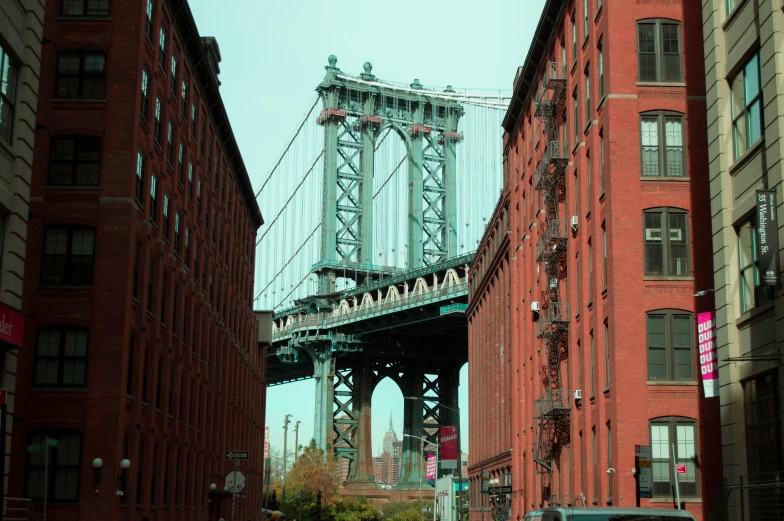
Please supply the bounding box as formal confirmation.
[502,0,567,134]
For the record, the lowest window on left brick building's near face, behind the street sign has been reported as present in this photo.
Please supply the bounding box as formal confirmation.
[27,430,82,502]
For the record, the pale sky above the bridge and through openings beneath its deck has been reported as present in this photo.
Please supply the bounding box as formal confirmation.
[190,0,544,454]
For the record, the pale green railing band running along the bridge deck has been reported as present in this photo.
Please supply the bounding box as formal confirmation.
[272,277,468,340]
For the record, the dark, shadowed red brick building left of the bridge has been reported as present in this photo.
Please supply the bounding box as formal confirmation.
[9,0,265,521]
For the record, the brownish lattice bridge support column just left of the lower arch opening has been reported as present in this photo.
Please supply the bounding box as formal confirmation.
[349,362,375,483]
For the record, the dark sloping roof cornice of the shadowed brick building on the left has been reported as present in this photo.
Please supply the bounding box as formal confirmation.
[167,0,264,229]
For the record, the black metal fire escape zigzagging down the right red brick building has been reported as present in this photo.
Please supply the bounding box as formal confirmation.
[533,62,571,505]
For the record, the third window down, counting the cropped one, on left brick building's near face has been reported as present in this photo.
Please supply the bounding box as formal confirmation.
[49,137,101,186]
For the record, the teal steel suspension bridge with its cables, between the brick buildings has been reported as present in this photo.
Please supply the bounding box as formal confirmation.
[254,56,510,488]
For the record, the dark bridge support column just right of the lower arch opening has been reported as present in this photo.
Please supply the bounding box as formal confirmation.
[398,366,426,487]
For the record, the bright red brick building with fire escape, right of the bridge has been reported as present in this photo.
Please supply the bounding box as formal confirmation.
[468,0,721,520]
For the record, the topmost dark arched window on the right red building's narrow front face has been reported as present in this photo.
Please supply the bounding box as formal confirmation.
[637,20,683,82]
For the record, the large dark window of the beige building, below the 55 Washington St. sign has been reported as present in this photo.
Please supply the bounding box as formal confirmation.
[743,372,784,477]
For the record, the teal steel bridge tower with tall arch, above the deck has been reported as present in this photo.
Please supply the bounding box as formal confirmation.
[314,56,464,295]
